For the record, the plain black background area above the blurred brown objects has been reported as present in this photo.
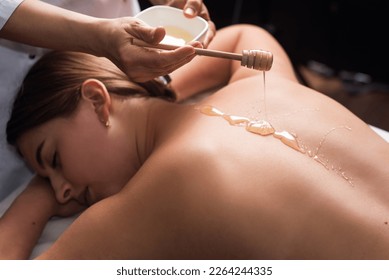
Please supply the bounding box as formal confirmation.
[141,0,389,83]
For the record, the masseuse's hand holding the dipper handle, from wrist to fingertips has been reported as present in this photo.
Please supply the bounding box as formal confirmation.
[97,17,195,82]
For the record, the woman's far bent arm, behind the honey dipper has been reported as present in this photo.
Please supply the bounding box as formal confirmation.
[171,24,296,101]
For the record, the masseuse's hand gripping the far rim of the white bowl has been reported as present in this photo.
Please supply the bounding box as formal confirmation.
[150,0,216,48]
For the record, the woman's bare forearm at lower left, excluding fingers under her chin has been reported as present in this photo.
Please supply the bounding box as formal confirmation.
[0,183,52,260]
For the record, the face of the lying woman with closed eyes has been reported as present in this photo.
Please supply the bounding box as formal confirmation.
[18,95,136,205]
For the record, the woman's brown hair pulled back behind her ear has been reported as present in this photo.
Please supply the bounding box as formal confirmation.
[6,51,175,146]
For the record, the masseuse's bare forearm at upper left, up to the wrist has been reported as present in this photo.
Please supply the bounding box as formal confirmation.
[0,0,104,55]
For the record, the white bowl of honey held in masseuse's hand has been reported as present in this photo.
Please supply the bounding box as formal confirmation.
[135,5,208,45]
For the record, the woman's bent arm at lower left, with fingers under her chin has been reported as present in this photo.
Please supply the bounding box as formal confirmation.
[0,176,83,259]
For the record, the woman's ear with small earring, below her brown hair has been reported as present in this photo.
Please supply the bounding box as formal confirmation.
[81,79,111,124]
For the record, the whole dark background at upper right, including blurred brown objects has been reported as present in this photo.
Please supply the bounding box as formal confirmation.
[140,0,389,130]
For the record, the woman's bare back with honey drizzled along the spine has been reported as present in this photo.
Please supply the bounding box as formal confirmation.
[142,69,389,259]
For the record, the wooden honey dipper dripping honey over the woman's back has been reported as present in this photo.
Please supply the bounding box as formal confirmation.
[130,38,273,71]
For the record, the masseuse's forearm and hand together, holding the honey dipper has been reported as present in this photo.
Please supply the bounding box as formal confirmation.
[0,0,199,82]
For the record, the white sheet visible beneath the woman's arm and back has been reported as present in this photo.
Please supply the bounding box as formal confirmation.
[0,126,389,259]
